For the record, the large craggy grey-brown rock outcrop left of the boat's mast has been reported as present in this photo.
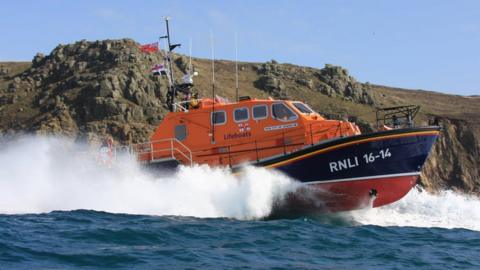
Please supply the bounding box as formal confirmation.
[0,39,172,141]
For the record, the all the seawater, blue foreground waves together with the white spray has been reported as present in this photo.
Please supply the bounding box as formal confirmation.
[0,138,480,269]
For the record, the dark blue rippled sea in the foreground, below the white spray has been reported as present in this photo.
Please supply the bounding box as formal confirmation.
[0,210,480,269]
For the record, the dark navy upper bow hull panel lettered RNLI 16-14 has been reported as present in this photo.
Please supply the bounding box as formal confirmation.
[256,127,438,182]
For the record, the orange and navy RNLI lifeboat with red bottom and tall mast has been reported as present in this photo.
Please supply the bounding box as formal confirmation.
[125,21,439,212]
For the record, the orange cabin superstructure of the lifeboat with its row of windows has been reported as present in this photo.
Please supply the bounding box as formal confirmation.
[137,97,360,166]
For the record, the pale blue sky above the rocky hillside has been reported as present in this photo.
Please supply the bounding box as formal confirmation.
[0,0,480,95]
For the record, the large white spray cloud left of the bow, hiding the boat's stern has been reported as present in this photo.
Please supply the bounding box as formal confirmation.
[0,138,297,219]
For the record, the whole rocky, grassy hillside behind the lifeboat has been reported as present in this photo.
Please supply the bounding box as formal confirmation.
[0,39,480,193]
